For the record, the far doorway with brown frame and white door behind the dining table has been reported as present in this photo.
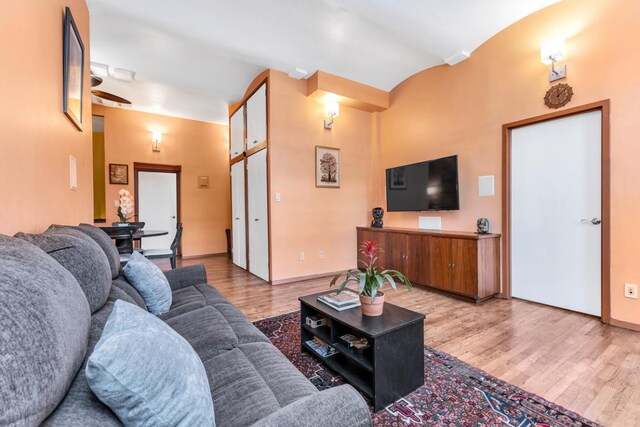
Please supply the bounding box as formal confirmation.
[133,163,182,249]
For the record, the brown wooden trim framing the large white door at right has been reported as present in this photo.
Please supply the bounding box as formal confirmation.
[501,99,611,323]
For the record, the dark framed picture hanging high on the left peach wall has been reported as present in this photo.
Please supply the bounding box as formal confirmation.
[62,7,84,131]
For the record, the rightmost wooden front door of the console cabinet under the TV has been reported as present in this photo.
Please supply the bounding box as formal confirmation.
[451,239,478,296]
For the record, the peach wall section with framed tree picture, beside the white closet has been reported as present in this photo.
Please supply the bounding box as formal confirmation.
[269,70,373,282]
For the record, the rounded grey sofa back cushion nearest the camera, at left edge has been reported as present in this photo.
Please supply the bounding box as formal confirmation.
[0,236,91,425]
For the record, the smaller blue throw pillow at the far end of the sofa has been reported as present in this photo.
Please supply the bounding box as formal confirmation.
[123,252,171,316]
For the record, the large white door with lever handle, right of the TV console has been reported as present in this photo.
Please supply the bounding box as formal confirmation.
[511,111,602,316]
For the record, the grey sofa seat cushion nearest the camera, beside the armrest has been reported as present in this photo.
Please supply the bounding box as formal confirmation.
[204,343,318,426]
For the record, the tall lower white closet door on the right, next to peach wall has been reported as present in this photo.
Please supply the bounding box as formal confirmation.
[247,150,269,281]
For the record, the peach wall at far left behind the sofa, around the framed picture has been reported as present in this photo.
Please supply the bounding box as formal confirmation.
[0,0,93,234]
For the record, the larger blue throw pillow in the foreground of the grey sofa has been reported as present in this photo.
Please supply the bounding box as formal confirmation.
[85,300,215,427]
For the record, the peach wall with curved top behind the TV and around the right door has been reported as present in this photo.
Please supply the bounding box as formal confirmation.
[376,0,640,324]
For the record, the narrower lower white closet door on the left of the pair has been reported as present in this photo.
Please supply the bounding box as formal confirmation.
[231,162,247,268]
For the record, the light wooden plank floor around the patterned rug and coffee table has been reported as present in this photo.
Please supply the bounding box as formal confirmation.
[166,256,640,427]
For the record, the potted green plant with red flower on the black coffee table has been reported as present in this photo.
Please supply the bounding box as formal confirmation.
[330,240,411,316]
